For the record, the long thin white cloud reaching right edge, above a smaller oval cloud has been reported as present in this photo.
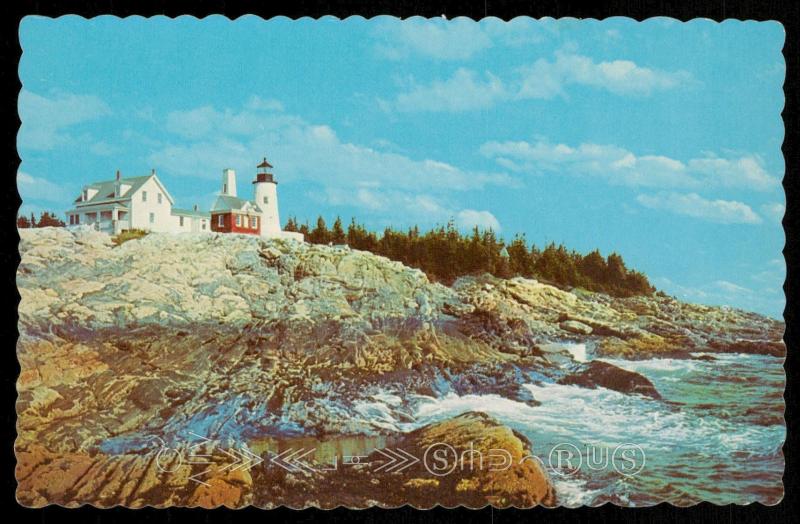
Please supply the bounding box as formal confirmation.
[480,139,779,191]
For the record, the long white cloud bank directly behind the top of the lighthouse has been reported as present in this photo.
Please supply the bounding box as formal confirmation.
[148,100,518,227]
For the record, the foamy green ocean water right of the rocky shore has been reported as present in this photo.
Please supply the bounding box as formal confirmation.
[416,354,786,506]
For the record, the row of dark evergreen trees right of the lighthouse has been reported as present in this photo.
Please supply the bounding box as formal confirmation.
[284,216,655,297]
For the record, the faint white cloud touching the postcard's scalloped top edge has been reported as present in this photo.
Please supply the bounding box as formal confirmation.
[374,18,492,60]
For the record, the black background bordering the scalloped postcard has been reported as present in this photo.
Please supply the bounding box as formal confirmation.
[0,0,800,524]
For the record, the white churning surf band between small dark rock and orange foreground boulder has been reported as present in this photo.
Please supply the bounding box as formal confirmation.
[406,378,780,452]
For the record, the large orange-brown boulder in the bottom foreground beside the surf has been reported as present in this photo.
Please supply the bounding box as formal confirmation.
[254,412,557,509]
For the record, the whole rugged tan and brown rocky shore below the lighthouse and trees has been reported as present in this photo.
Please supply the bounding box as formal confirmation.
[15,228,785,507]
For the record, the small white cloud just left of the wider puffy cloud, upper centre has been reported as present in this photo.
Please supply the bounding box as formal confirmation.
[391,68,507,112]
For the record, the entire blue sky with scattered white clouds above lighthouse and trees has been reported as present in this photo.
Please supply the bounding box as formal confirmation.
[17,16,785,317]
